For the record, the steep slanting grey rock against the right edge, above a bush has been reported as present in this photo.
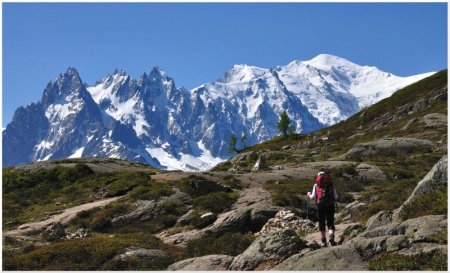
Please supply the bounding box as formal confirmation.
[392,155,448,221]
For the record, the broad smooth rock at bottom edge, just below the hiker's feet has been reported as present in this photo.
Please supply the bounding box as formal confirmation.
[273,245,368,271]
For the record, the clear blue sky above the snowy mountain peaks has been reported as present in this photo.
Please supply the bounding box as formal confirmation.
[2,3,447,127]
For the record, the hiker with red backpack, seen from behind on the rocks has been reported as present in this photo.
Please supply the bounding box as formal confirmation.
[307,171,338,247]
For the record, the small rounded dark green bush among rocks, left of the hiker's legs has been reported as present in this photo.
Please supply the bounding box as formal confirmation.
[194,189,239,213]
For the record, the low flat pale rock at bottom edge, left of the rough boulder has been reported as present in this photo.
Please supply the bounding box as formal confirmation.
[167,255,233,271]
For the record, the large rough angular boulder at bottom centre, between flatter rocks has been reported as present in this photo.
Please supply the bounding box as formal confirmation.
[229,229,306,271]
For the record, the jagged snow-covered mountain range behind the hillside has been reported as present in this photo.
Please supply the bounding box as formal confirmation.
[3,54,433,170]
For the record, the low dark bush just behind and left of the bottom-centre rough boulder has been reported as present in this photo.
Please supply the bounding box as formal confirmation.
[183,233,255,259]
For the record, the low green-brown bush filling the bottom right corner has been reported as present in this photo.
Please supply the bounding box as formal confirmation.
[369,253,447,271]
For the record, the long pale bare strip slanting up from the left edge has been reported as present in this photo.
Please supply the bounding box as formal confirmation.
[3,196,122,236]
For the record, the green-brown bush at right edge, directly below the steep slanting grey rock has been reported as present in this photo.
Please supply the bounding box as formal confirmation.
[400,188,448,220]
